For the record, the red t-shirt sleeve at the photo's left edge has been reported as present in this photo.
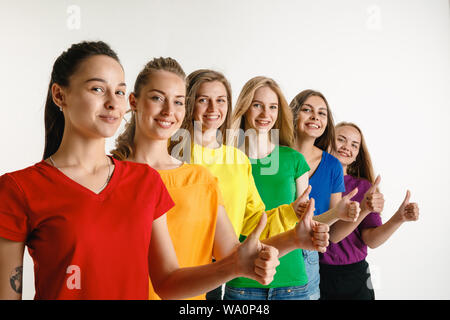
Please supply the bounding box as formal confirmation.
[0,174,29,242]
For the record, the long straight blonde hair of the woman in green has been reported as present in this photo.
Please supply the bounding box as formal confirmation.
[232,76,294,147]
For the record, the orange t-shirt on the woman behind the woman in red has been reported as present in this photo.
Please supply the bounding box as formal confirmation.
[149,163,223,300]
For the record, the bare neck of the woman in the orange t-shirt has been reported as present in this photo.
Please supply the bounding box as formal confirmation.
[128,131,180,170]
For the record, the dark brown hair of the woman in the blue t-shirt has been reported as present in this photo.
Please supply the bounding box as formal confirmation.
[289,89,336,152]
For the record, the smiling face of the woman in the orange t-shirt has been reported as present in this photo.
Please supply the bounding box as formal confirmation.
[130,70,186,140]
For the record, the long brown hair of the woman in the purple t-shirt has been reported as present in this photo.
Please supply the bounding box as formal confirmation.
[335,122,375,183]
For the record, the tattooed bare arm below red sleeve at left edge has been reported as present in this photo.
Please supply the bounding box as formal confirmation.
[0,238,25,300]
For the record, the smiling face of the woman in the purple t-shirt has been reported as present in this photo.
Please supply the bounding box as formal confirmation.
[334,126,361,167]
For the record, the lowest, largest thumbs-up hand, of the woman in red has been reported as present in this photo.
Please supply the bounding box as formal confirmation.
[236,213,280,285]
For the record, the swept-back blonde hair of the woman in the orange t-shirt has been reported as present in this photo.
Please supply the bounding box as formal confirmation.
[111,57,186,160]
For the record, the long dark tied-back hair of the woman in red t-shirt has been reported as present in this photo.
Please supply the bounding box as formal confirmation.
[43,41,120,159]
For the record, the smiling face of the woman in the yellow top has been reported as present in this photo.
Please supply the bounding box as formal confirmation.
[194,81,228,132]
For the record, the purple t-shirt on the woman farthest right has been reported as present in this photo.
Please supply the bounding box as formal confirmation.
[320,175,383,265]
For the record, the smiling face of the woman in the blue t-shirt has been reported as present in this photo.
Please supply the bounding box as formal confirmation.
[297,96,328,138]
